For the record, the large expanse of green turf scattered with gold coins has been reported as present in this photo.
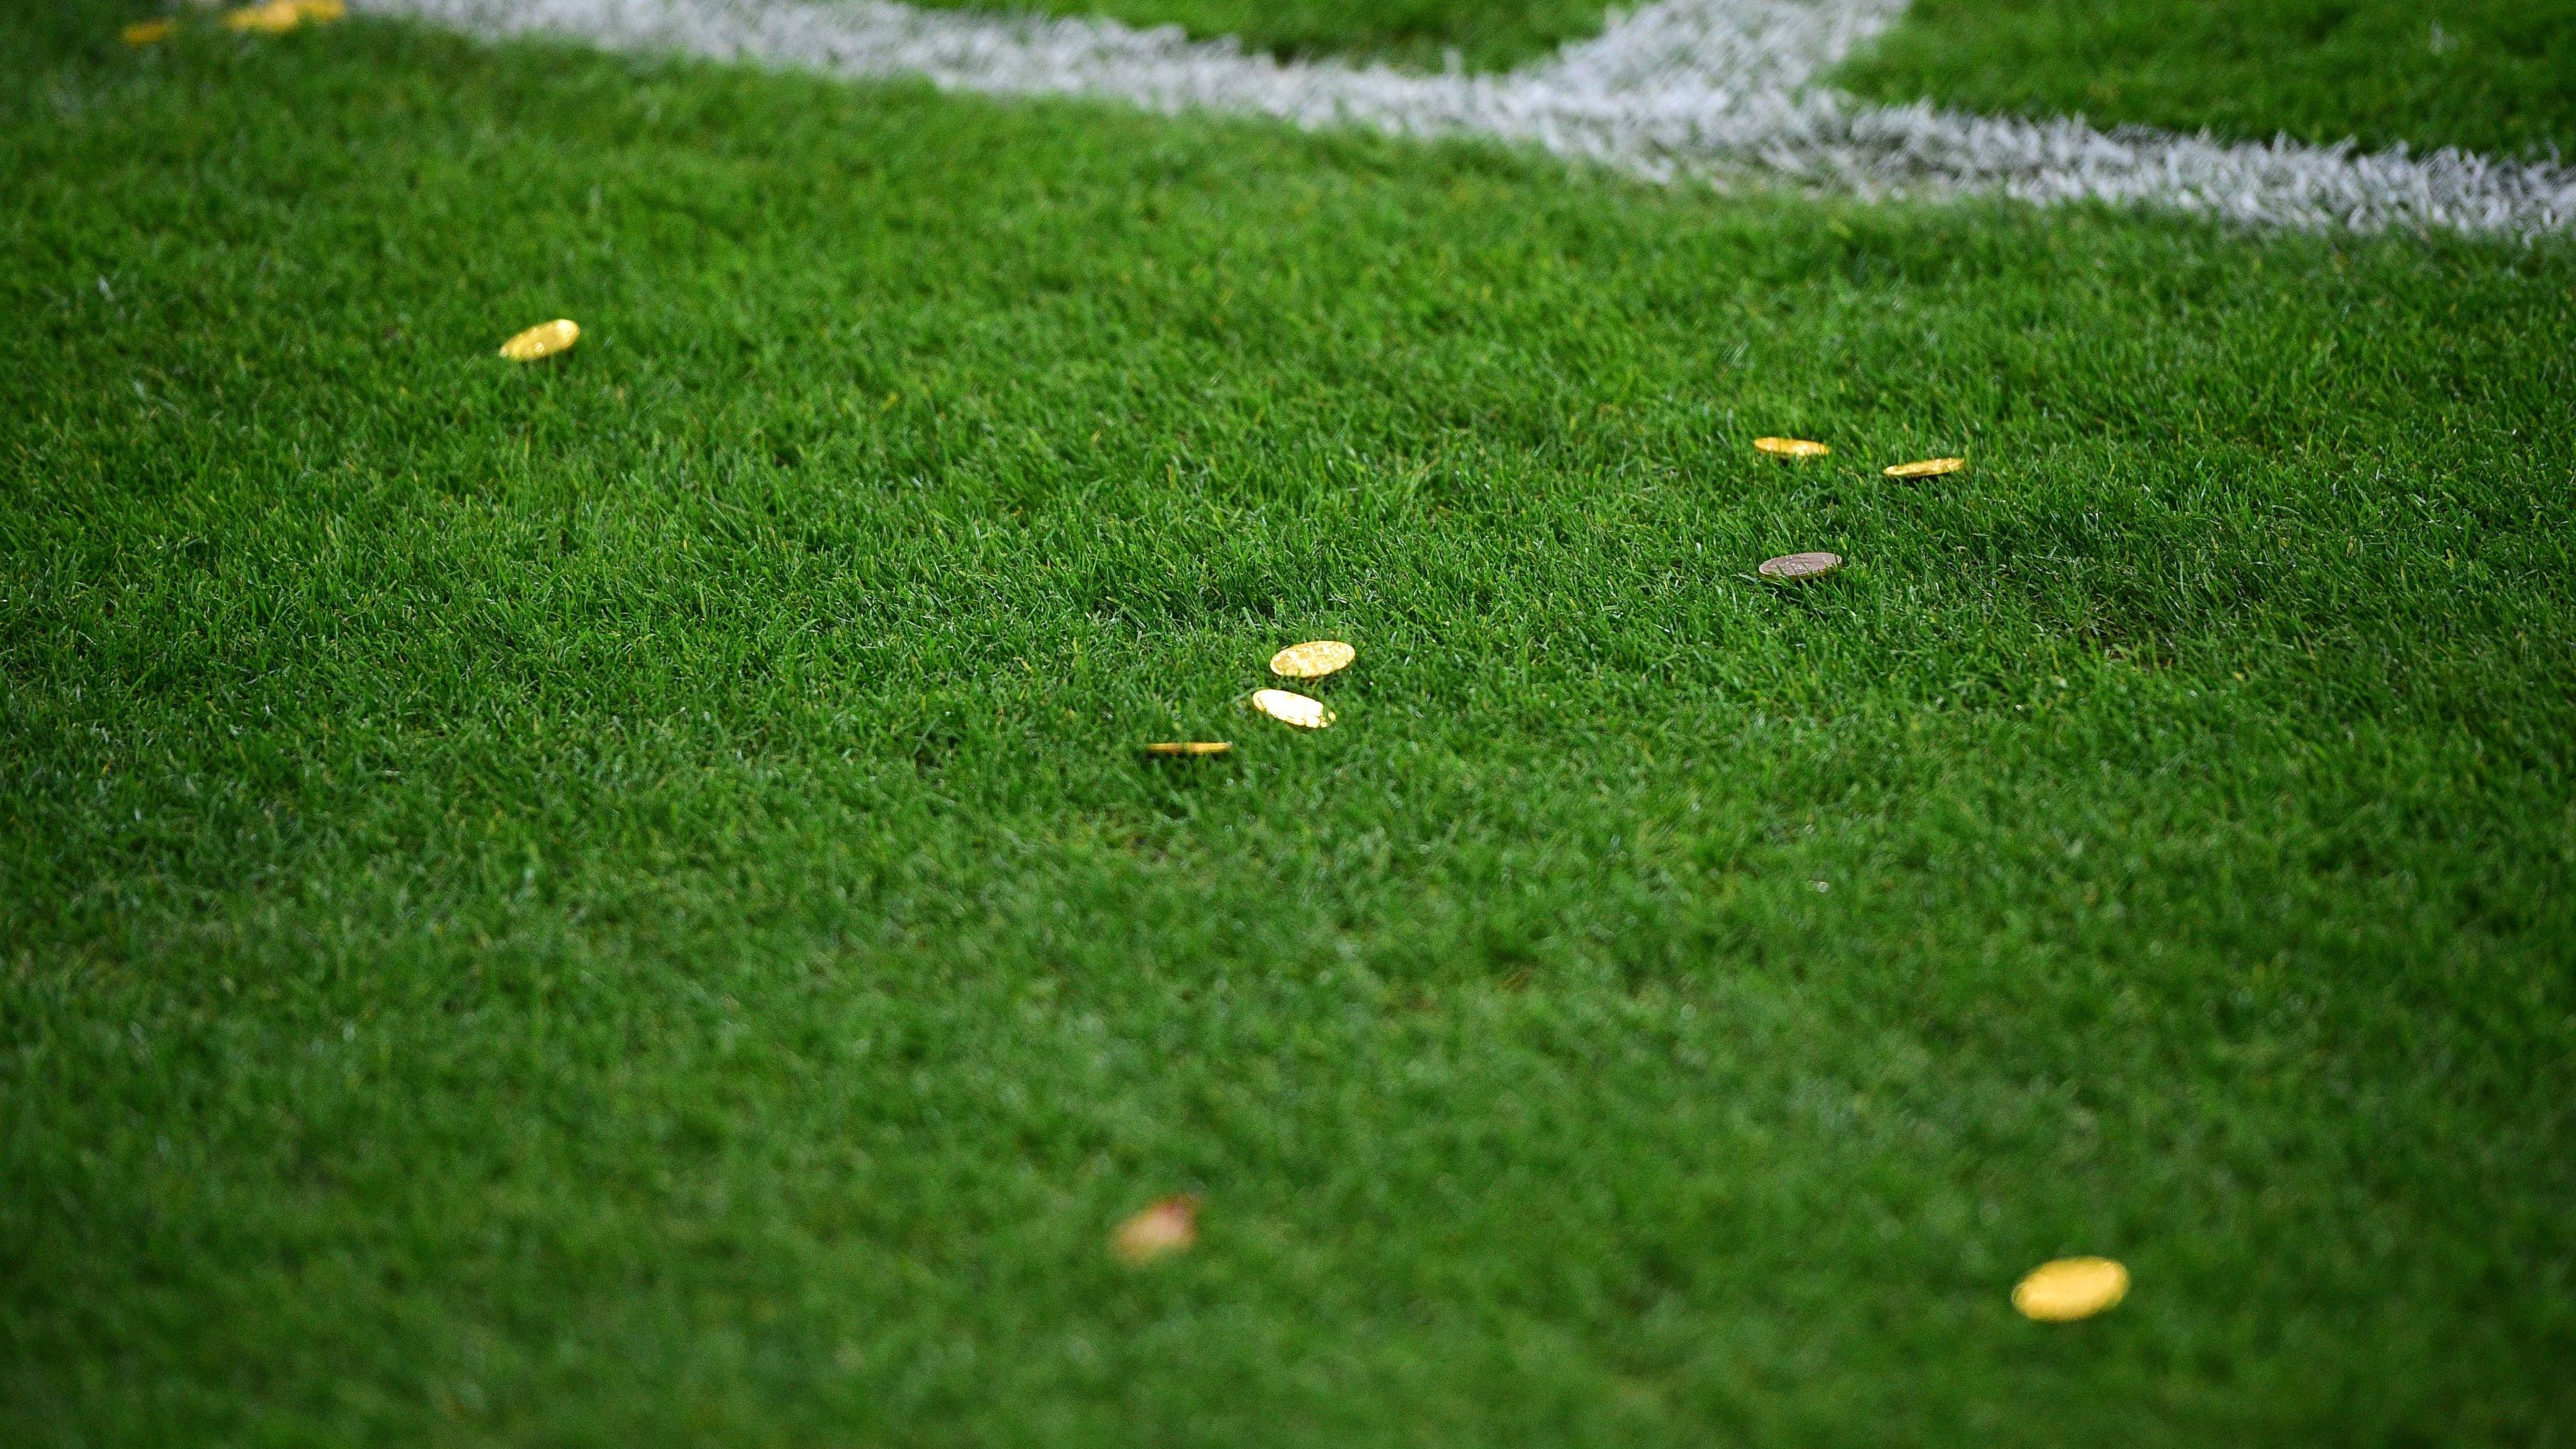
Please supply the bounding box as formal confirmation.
[0,8,2576,1446]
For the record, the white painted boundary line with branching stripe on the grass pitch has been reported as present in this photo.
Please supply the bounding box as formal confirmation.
[358,0,2576,235]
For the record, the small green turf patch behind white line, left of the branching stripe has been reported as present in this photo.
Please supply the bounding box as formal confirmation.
[924,0,1607,69]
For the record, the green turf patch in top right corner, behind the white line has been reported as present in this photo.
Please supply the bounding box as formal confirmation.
[1834,0,2576,160]
